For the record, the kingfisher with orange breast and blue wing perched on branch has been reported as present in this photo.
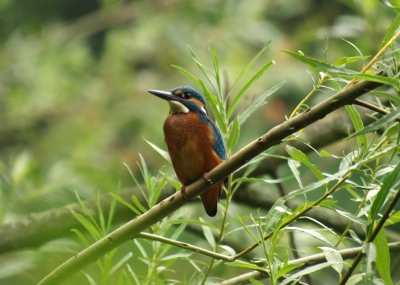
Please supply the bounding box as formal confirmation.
[149,86,226,217]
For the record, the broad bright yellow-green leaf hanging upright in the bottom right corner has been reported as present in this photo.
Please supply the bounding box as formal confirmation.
[373,228,393,285]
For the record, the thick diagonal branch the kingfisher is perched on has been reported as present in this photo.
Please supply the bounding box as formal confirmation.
[39,65,396,285]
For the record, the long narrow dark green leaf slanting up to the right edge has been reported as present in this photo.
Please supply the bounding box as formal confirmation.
[367,163,400,236]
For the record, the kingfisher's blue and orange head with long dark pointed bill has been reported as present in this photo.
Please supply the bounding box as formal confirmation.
[149,86,207,115]
